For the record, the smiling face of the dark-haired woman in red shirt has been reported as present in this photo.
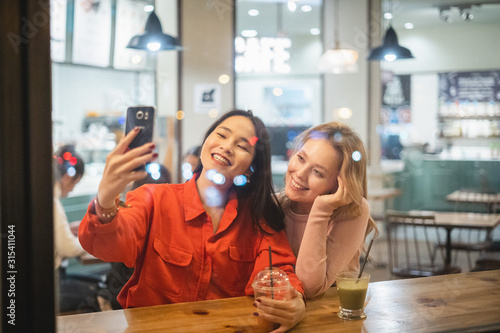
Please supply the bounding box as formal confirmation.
[201,116,256,186]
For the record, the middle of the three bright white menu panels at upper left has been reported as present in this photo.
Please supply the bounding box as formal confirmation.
[73,0,112,67]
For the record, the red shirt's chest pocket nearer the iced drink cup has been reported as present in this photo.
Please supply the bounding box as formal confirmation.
[222,245,255,294]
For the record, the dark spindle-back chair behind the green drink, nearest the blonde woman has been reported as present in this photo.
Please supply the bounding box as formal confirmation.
[386,210,461,278]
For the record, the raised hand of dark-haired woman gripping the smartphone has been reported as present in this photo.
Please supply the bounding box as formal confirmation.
[97,129,158,207]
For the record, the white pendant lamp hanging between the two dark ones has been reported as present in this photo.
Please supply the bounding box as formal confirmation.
[318,0,359,74]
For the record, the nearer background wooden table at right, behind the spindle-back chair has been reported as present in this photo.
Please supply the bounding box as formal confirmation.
[410,210,500,265]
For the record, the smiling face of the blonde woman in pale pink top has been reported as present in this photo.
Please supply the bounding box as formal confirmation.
[285,139,342,214]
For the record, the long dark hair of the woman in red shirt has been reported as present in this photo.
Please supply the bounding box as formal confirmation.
[194,110,285,234]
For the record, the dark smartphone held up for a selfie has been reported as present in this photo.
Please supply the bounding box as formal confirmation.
[125,106,156,149]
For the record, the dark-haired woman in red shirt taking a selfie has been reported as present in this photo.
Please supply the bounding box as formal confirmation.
[79,110,305,332]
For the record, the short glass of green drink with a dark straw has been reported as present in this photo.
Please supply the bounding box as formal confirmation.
[336,272,370,320]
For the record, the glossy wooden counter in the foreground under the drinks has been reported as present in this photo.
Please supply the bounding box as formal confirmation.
[57,270,500,333]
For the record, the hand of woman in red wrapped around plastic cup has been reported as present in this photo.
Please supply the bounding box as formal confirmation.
[254,289,306,333]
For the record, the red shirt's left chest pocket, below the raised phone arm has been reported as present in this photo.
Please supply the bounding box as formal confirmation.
[146,237,193,296]
